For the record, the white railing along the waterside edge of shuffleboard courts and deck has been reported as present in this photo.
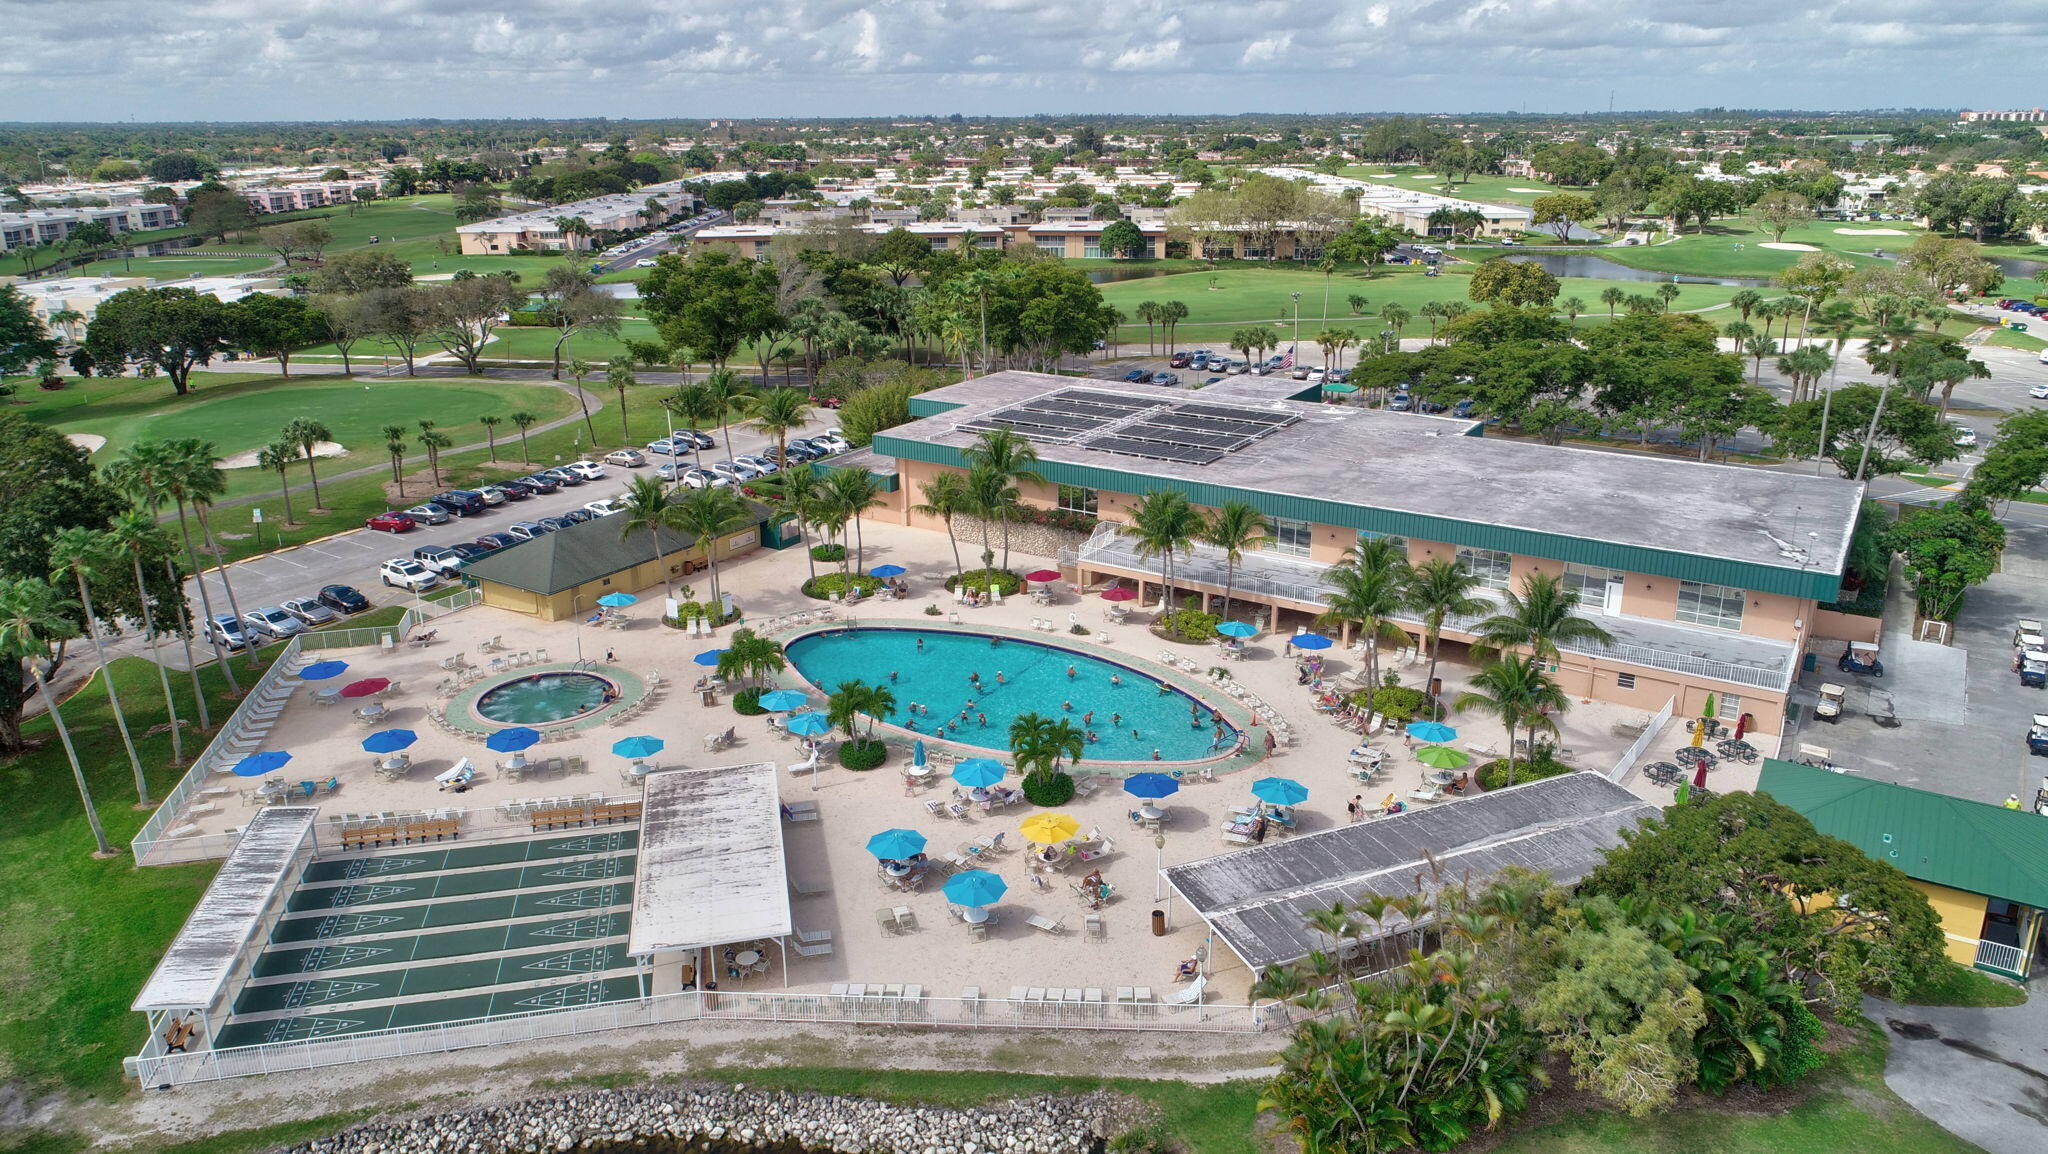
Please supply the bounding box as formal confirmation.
[125,990,1261,1086]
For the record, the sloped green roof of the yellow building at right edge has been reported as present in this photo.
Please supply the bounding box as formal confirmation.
[1757,758,2048,910]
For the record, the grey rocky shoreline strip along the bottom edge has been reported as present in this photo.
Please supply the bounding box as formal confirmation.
[289,1084,1143,1154]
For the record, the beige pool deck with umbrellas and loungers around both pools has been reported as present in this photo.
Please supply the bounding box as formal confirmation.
[167,525,1645,1025]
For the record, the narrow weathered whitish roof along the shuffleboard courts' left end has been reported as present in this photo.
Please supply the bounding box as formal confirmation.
[131,806,319,1013]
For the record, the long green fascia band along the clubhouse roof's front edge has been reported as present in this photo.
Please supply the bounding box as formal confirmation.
[872,432,1841,601]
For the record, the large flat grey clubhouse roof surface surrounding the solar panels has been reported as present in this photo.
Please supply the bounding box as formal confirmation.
[883,371,1864,576]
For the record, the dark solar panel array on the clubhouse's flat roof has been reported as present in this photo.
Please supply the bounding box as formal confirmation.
[961,389,1300,465]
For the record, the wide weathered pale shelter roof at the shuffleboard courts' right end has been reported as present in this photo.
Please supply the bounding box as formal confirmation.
[627,760,791,957]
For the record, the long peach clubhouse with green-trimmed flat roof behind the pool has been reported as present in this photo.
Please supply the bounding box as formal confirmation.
[834,371,1868,734]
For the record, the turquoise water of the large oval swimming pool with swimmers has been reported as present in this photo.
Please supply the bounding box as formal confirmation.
[786,627,1237,760]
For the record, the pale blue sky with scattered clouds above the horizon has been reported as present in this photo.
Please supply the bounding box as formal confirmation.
[0,0,2048,121]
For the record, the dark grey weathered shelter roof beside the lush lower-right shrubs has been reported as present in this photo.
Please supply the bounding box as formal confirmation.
[1163,771,1657,970]
